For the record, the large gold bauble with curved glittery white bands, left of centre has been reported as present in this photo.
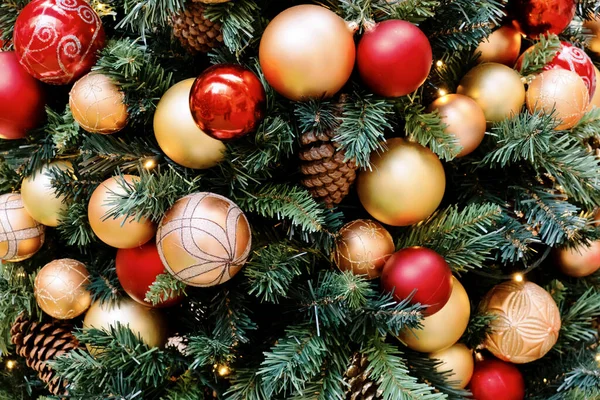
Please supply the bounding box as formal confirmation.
[156,192,252,287]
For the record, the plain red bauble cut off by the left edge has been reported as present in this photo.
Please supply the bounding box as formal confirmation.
[0,51,44,139]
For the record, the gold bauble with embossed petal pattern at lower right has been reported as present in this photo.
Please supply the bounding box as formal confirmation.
[481,281,560,364]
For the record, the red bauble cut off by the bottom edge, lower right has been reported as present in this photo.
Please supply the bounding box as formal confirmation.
[469,358,525,400]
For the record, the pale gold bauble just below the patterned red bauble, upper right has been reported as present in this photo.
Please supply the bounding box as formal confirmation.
[527,69,590,129]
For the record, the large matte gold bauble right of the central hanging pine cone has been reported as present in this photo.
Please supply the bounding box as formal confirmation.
[358,138,446,226]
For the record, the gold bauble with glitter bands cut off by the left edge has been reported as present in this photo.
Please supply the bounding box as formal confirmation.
[0,193,45,262]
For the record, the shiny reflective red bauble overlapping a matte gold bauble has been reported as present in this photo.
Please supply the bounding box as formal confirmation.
[190,64,267,140]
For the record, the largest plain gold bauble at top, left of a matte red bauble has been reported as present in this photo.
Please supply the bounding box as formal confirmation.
[259,4,356,101]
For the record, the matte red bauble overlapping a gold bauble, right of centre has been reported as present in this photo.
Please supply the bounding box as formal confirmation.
[381,247,452,315]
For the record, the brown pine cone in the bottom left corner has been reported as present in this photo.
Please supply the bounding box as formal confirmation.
[10,314,80,396]
